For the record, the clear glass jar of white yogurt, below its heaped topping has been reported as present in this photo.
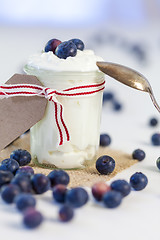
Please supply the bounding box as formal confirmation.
[24,65,104,169]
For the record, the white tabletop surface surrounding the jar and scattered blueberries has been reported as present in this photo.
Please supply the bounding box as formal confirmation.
[0,1,160,240]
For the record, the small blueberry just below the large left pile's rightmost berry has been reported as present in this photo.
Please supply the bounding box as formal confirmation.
[59,205,74,222]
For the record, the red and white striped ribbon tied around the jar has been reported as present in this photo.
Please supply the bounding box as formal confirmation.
[0,81,105,145]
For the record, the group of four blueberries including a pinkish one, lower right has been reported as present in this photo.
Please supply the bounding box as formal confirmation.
[92,172,148,208]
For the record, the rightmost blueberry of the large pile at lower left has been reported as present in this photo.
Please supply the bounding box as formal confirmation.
[66,187,89,208]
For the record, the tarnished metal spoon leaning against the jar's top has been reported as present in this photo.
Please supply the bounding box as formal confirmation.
[96,62,160,112]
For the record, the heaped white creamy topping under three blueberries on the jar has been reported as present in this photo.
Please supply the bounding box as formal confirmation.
[27,50,104,72]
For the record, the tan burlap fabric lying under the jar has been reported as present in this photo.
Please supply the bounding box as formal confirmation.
[0,133,137,187]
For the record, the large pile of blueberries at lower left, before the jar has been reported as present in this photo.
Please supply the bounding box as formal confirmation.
[0,149,89,228]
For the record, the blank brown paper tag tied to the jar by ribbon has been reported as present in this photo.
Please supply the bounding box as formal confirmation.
[0,74,47,150]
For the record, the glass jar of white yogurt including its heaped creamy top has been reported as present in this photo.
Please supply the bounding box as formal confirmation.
[24,45,104,169]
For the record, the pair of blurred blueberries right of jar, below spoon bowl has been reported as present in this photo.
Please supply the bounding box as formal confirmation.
[103,91,122,111]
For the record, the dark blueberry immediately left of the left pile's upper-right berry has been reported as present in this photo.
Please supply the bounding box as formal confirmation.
[31,173,50,194]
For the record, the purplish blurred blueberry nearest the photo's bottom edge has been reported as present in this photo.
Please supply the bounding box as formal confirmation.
[23,208,43,228]
